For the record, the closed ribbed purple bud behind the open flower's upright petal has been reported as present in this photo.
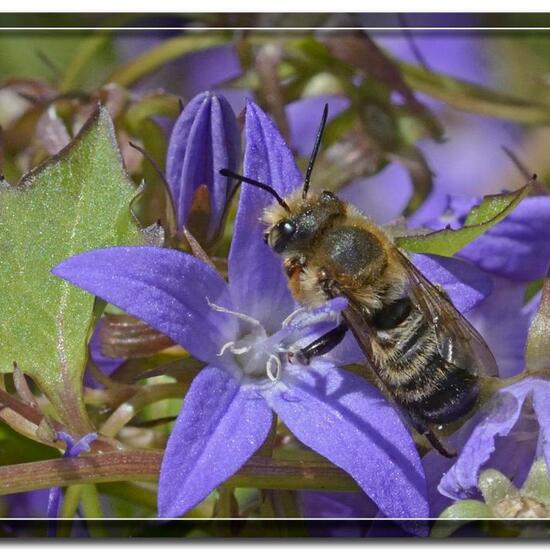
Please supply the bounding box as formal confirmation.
[166,92,241,239]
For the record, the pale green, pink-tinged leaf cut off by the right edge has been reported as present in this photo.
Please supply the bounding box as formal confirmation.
[525,273,550,371]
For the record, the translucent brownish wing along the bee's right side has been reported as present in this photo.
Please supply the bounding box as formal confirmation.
[398,251,498,376]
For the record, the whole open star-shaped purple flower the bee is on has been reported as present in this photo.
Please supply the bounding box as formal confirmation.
[53,103,428,528]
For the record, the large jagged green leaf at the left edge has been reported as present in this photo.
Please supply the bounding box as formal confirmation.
[0,108,139,434]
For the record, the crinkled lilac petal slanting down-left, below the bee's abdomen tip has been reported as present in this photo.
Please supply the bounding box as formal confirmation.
[438,379,533,499]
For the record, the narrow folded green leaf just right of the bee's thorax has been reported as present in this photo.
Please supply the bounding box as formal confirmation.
[395,184,531,256]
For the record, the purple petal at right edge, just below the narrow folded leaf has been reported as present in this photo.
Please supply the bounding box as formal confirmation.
[459,196,550,281]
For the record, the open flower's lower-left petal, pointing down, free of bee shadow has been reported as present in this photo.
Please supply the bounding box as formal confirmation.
[158,367,273,517]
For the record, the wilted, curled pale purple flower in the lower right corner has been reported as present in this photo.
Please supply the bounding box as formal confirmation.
[438,377,550,499]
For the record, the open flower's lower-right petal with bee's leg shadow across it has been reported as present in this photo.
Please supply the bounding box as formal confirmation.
[268,362,428,518]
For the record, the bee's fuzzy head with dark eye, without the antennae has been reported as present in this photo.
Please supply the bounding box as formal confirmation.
[263,191,345,254]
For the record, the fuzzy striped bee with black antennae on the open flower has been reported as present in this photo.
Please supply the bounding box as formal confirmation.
[222,106,497,457]
